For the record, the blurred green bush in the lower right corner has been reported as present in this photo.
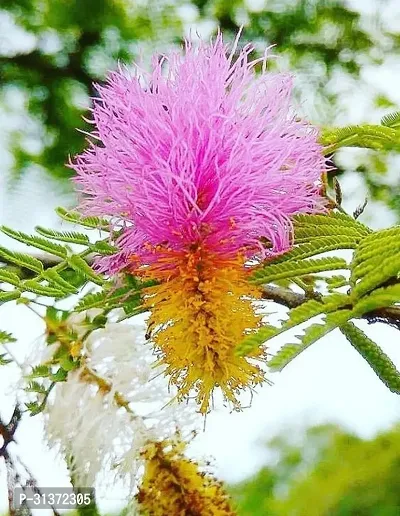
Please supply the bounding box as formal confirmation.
[231,425,400,516]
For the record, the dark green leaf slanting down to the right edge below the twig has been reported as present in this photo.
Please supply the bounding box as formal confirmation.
[340,322,400,394]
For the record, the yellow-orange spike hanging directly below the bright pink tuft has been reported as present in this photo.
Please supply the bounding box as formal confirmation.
[136,246,265,414]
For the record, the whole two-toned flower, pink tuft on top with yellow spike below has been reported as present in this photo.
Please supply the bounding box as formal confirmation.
[72,35,326,413]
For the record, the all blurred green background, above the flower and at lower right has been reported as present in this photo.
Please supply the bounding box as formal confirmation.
[0,0,400,516]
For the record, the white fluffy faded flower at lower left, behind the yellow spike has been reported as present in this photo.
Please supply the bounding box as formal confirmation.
[46,323,195,490]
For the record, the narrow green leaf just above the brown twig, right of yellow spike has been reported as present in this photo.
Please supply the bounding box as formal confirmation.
[250,257,348,284]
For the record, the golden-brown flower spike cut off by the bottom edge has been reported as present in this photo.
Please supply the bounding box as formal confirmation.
[136,441,235,516]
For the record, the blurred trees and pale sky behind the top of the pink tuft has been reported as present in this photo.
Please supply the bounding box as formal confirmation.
[0,0,400,221]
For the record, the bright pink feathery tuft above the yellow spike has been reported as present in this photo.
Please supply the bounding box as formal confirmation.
[71,31,326,273]
